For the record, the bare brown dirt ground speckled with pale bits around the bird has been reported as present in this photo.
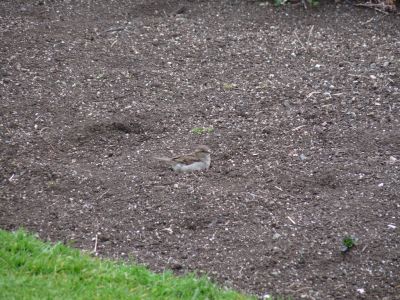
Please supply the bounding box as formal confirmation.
[0,0,400,300]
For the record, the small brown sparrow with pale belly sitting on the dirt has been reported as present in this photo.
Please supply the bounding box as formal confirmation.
[154,145,211,172]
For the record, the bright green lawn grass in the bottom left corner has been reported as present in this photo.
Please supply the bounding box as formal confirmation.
[0,230,254,300]
